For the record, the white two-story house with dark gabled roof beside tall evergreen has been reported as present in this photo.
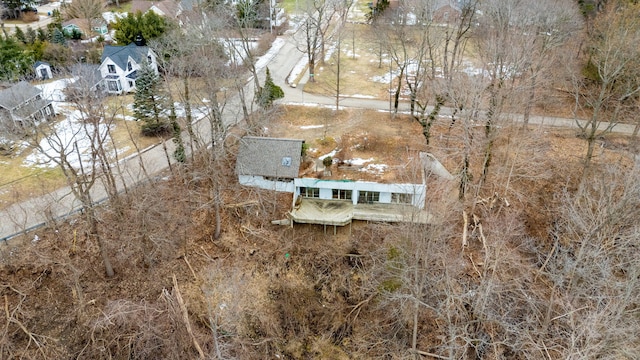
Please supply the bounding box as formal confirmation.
[100,43,158,94]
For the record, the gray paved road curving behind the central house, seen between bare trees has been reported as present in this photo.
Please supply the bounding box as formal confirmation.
[0,28,633,241]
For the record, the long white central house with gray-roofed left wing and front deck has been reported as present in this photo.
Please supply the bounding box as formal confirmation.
[236,137,438,226]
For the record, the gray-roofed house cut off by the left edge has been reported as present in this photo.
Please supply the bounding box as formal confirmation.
[0,81,55,127]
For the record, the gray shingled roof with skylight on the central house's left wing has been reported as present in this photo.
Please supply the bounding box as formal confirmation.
[236,136,304,179]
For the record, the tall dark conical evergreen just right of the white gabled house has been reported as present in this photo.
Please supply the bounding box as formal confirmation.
[133,61,171,136]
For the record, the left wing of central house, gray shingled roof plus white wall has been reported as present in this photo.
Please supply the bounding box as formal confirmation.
[236,136,304,193]
